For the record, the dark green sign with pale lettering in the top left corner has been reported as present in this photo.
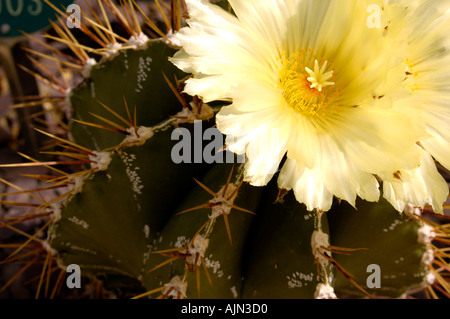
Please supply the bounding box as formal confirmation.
[0,0,73,38]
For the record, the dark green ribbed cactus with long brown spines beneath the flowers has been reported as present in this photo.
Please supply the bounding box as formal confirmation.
[3,0,450,299]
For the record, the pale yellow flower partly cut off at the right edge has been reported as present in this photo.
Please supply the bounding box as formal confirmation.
[380,0,450,213]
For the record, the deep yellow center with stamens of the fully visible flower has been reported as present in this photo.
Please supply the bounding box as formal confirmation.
[279,51,339,117]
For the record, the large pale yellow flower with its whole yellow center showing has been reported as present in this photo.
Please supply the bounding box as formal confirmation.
[171,0,448,215]
